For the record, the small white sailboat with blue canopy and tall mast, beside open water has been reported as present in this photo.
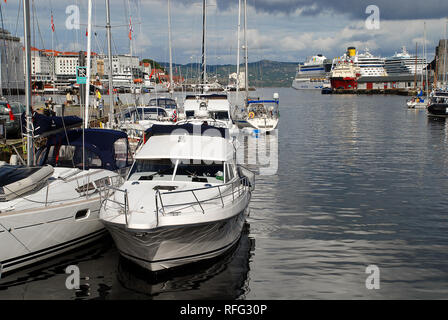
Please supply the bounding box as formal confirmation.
[234,0,280,133]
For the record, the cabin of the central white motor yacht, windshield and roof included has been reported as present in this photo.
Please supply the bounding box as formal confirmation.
[128,123,237,185]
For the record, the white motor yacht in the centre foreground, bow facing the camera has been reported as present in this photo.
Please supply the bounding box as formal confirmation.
[100,123,255,271]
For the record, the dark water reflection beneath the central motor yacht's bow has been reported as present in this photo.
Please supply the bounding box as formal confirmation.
[110,224,255,300]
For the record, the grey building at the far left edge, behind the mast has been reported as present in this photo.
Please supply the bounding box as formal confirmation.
[0,29,25,94]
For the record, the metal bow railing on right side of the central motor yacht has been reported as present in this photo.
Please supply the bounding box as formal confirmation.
[155,174,255,216]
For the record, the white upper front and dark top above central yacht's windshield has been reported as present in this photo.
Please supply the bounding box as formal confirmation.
[135,123,234,161]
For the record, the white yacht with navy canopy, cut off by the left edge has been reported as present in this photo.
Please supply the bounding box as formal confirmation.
[0,129,131,275]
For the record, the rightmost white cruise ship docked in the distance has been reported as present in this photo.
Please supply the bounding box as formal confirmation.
[385,47,427,76]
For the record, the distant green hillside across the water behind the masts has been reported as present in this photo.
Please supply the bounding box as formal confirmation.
[159,60,297,87]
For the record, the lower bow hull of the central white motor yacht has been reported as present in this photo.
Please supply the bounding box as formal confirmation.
[105,208,248,271]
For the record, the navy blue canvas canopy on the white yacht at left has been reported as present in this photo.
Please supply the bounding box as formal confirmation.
[37,129,132,171]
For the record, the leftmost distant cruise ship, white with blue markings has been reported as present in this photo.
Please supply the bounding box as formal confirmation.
[292,54,331,90]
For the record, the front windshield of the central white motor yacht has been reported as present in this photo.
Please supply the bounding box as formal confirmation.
[128,159,224,183]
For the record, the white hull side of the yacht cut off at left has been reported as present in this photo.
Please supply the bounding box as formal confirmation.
[0,197,106,275]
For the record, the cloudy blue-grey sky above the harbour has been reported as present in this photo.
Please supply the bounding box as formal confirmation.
[0,0,448,64]
